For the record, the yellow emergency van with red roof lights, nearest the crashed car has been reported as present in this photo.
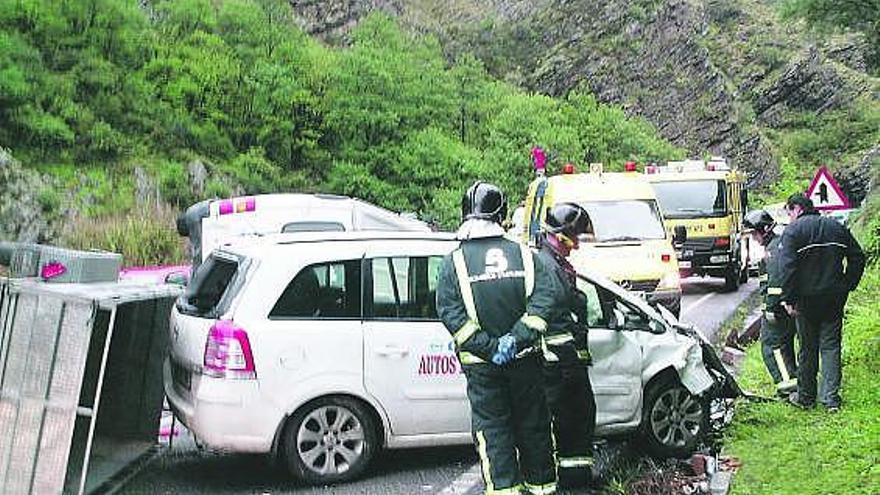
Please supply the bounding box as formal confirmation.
[522,162,681,315]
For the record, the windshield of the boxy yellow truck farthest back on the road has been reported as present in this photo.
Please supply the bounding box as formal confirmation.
[653,180,726,218]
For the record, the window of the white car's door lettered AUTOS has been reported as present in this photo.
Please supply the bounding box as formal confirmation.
[365,256,443,320]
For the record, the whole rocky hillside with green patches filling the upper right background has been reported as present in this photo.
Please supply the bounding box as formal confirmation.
[291,0,880,202]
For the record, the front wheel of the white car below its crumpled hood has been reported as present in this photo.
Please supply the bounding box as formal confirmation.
[642,376,709,457]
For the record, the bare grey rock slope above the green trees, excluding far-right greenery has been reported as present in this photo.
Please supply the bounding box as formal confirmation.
[291,0,880,195]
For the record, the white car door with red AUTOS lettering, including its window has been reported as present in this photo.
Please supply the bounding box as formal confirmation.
[363,241,470,435]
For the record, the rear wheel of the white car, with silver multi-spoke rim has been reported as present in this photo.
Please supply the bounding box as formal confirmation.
[283,397,379,485]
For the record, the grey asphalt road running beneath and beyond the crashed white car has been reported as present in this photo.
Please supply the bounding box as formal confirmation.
[115,278,757,495]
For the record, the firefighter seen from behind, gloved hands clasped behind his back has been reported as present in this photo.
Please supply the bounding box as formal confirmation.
[437,182,561,494]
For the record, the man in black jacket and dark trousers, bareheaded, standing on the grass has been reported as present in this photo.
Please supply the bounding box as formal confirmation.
[779,194,865,412]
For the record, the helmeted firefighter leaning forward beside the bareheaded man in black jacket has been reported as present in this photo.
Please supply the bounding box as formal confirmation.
[743,210,797,397]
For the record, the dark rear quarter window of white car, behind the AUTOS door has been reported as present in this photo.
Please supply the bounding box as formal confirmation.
[269,259,361,319]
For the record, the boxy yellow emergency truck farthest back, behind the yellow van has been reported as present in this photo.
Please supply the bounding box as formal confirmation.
[645,157,749,291]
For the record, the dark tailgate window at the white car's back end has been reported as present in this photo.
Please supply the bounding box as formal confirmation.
[177,254,240,317]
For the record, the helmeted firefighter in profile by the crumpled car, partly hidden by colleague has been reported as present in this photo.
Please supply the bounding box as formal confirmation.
[539,203,596,486]
